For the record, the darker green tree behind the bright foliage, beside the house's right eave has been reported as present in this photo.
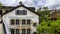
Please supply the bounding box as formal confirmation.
[37,7,50,22]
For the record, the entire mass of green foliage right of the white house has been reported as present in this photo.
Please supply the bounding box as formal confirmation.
[37,8,60,34]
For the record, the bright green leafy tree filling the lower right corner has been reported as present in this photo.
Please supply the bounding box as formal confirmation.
[37,19,60,34]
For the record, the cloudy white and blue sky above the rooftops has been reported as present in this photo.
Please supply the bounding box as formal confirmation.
[0,0,60,9]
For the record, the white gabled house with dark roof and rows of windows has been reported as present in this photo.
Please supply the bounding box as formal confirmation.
[0,2,39,34]
